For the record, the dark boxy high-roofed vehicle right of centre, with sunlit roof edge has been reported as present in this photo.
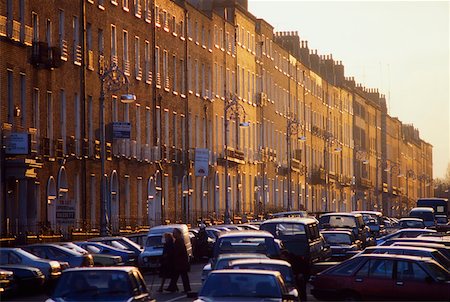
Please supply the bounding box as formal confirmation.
[260,217,331,276]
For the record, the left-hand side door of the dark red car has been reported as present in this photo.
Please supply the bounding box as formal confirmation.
[350,259,394,300]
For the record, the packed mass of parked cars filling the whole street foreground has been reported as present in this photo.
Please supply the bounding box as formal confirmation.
[0,198,450,302]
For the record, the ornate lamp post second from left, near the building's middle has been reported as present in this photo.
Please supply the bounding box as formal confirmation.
[223,97,249,224]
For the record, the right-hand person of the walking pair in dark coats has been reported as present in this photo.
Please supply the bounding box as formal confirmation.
[166,229,191,292]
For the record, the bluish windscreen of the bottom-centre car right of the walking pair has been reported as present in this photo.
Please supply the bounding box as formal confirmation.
[199,273,281,299]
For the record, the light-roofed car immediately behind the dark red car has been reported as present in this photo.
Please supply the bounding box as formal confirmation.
[361,245,450,270]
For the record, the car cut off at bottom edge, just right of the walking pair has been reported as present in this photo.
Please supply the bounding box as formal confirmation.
[195,269,297,302]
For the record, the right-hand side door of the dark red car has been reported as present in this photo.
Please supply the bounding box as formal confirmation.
[392,260,442,301]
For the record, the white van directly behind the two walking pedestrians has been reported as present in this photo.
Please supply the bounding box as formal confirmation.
[138,224,193,269]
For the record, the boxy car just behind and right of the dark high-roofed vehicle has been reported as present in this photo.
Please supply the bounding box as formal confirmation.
[319,212,370,247]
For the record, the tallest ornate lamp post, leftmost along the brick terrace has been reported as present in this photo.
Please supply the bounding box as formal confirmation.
[99,63,136,236]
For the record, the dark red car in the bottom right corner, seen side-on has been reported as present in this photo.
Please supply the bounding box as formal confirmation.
[311,254,450,301]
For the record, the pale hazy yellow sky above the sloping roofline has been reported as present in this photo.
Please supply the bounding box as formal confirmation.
[248,0,450,178]
